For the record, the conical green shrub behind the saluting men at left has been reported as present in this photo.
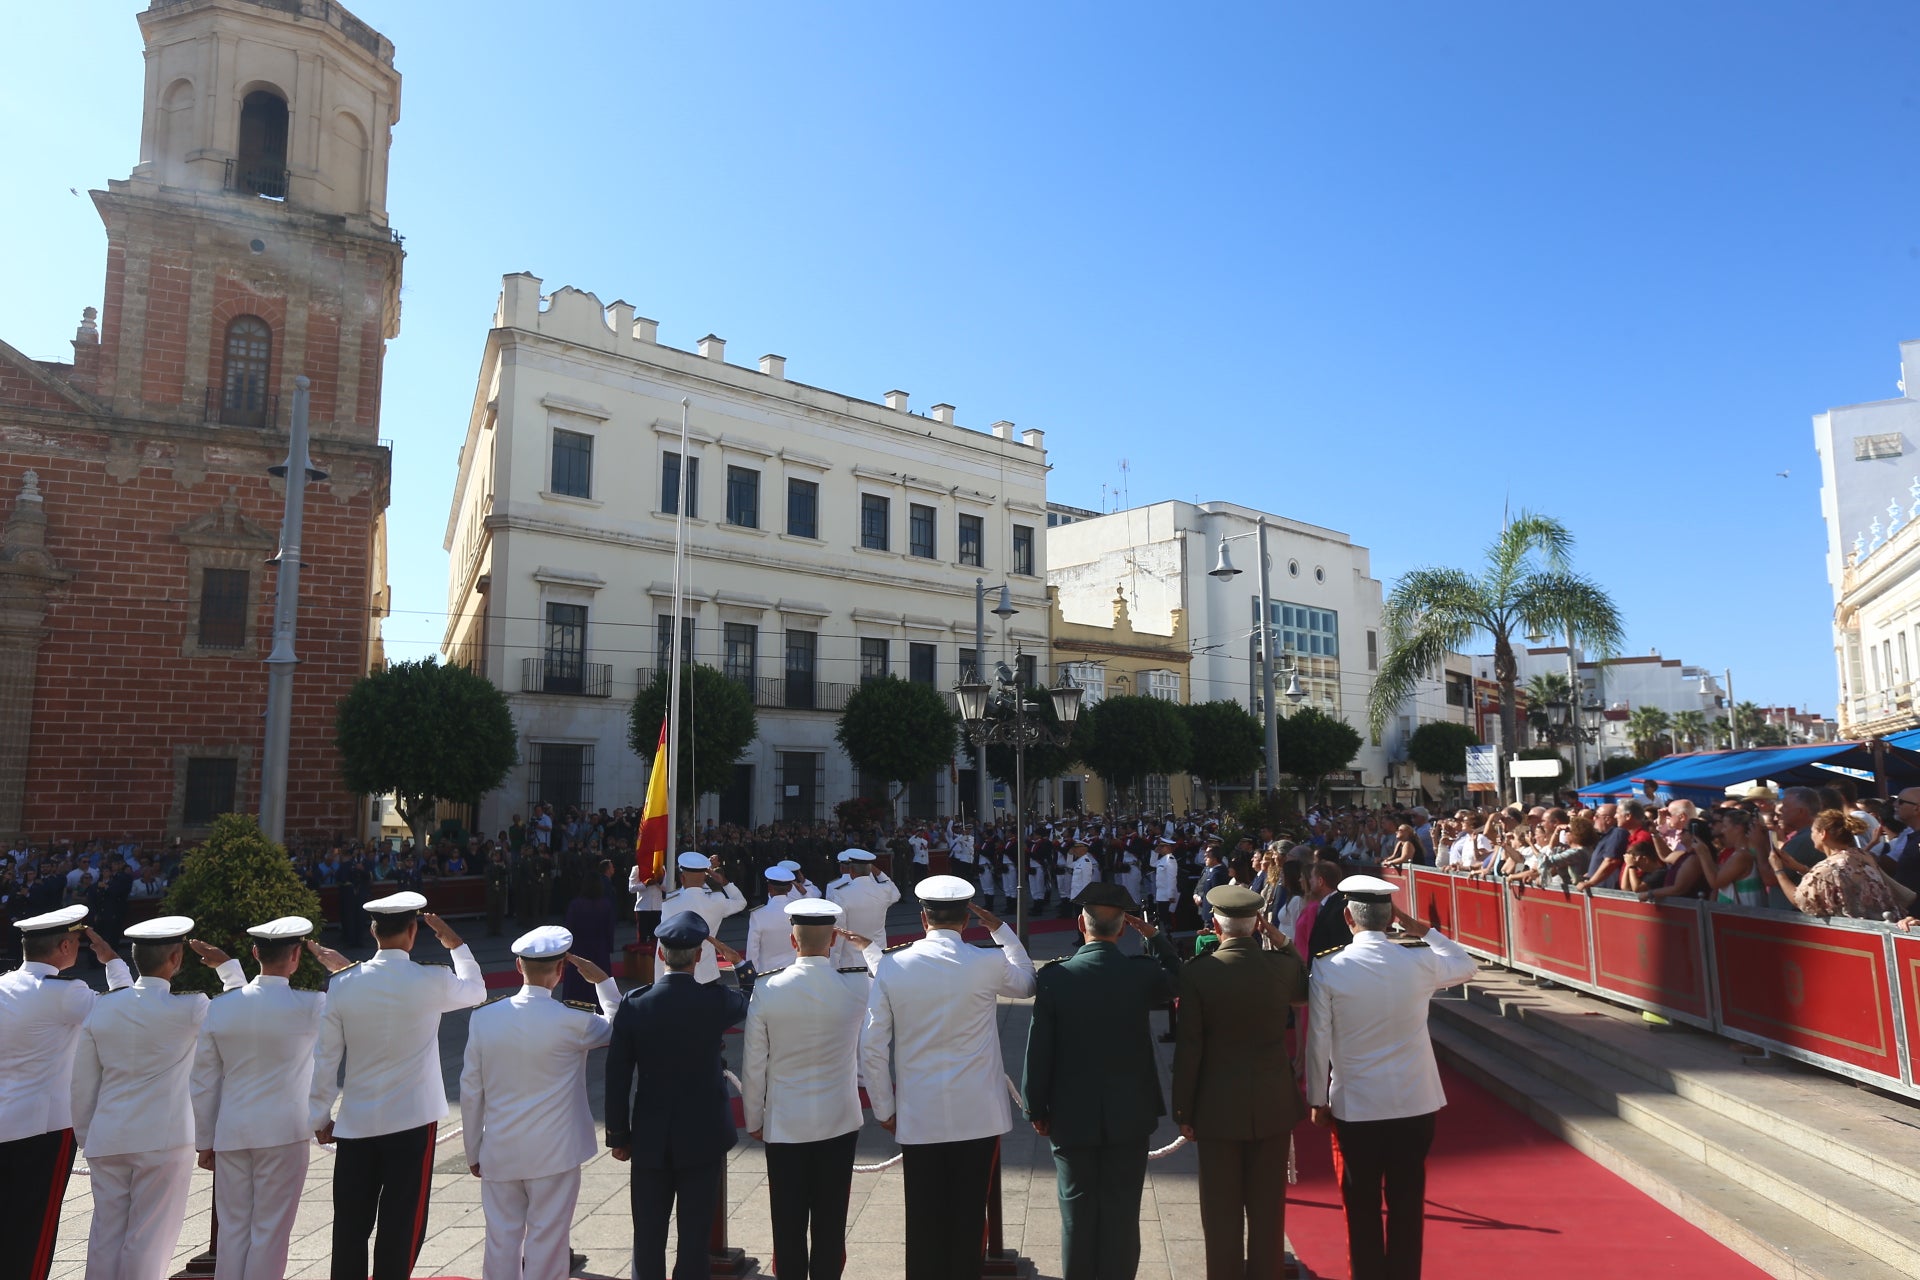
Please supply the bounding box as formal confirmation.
[165,814,326,994]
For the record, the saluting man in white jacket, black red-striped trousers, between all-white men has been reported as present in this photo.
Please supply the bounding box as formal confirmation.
[307,892,486,1280]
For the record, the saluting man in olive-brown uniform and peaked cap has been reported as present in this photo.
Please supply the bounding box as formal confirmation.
[1173,885,1308,1280]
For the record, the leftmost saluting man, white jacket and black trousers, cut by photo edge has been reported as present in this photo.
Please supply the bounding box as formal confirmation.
[0,906,132,1280]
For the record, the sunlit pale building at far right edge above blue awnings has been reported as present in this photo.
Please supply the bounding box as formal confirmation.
[1812,342,1920,737]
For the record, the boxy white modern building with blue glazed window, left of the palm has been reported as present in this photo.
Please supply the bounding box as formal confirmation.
[1046,501,1390,798]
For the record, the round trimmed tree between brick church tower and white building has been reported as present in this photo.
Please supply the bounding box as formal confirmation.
[336,656,518,844]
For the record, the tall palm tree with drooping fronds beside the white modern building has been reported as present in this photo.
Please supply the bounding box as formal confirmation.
[1367,510,1622,750]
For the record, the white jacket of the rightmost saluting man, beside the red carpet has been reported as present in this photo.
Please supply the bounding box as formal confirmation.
[1308,929,1476,1121]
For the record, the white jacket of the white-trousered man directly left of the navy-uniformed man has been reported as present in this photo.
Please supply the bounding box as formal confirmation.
[461,979,620,1180]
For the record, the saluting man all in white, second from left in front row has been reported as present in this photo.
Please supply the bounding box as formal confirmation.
[73,915,246,1280]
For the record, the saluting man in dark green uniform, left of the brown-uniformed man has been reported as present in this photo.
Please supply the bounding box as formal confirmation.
[1020,883,1181,1280]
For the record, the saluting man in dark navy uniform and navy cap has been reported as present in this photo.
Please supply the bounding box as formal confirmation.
[607,909,747,1280]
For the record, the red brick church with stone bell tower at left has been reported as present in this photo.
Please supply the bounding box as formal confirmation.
[0,0,403,842]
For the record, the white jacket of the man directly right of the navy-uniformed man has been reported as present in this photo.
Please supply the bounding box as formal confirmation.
[739,948,879,1142]
